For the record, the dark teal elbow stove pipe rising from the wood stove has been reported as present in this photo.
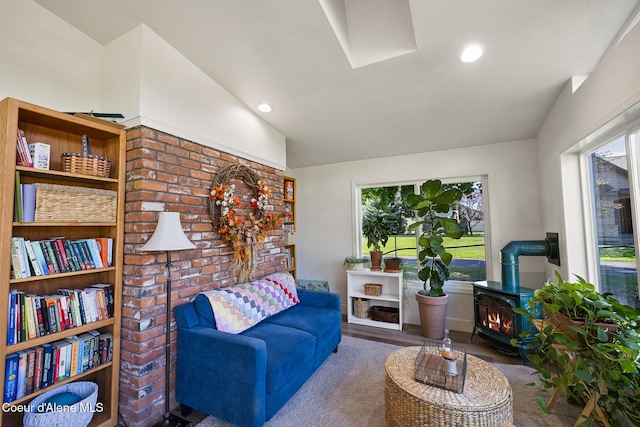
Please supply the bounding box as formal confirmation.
[500,233,559,290]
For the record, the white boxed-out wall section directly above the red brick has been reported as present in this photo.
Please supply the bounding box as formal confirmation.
[105,25,286,170]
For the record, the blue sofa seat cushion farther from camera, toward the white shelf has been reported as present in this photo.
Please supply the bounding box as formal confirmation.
[263,305,342,351]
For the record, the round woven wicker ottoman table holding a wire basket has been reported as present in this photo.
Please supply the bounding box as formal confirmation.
[384,347,513,427]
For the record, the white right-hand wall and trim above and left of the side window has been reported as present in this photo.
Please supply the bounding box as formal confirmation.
[537,26,640,283]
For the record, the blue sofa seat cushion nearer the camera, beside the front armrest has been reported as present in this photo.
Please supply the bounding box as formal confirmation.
[241,322,316,393]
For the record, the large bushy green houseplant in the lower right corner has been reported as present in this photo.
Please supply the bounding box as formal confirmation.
[512,272,640,426]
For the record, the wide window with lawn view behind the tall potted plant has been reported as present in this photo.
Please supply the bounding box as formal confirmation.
[359,177,487,281]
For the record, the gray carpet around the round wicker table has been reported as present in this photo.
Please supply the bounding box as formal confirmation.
[197,336,581,427]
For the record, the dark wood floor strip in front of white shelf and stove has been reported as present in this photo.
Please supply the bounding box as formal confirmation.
[342,322,522,365]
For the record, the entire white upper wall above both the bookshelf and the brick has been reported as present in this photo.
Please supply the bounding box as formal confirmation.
[0,0,286,169]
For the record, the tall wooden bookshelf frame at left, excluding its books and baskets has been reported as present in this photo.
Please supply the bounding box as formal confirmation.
[0,98,126,427]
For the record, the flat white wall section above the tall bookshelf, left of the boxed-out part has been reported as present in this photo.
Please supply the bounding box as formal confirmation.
[0,0,102,111]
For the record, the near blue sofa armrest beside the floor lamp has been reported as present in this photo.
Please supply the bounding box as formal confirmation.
[176,326,267,426]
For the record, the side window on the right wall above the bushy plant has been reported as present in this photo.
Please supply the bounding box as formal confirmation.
[587,131,640,307]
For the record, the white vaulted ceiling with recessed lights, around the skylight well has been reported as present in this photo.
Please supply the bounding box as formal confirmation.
[36,0,638,168]
